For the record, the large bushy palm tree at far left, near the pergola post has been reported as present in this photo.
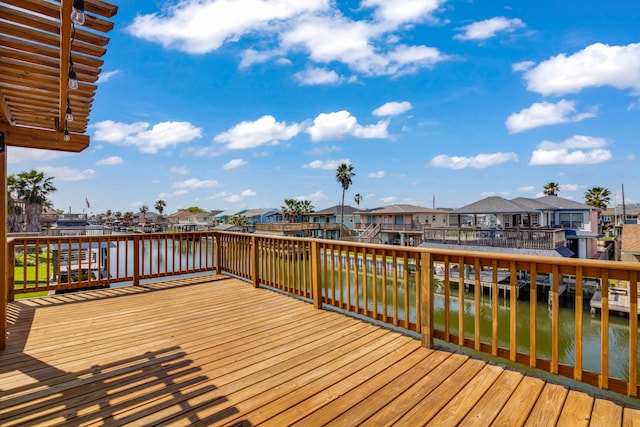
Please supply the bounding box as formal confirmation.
[7,169,57,232]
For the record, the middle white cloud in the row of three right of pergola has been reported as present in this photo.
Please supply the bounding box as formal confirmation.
[213,115,301,150]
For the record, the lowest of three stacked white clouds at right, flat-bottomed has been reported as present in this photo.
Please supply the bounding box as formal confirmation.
[529,135,612,166]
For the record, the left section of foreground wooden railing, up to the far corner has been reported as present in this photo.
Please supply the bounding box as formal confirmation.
[8,232,215,299]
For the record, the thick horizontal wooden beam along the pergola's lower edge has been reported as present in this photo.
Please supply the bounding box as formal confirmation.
[0,123,89,153]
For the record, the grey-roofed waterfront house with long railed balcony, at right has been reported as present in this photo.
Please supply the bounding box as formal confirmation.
[424,196,600,258]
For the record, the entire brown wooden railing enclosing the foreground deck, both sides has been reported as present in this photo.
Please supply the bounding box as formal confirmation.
[5,232,640,397]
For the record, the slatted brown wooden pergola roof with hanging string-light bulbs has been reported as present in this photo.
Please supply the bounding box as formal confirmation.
[0,0,118,152]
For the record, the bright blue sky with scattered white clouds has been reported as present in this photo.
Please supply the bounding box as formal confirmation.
[8,0,640,213]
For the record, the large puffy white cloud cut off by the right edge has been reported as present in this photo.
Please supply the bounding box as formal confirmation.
[514,43,640,96]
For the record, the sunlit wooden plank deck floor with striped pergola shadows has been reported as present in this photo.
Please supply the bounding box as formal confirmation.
[0,275,640,427]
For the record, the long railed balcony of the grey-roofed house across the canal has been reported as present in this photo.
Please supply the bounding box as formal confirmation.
[423,227,566,250]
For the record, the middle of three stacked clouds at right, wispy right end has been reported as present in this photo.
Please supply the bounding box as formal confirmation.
[505,99,597,133]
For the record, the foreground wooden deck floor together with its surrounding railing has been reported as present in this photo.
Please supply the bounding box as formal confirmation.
[0,232,640,426]
